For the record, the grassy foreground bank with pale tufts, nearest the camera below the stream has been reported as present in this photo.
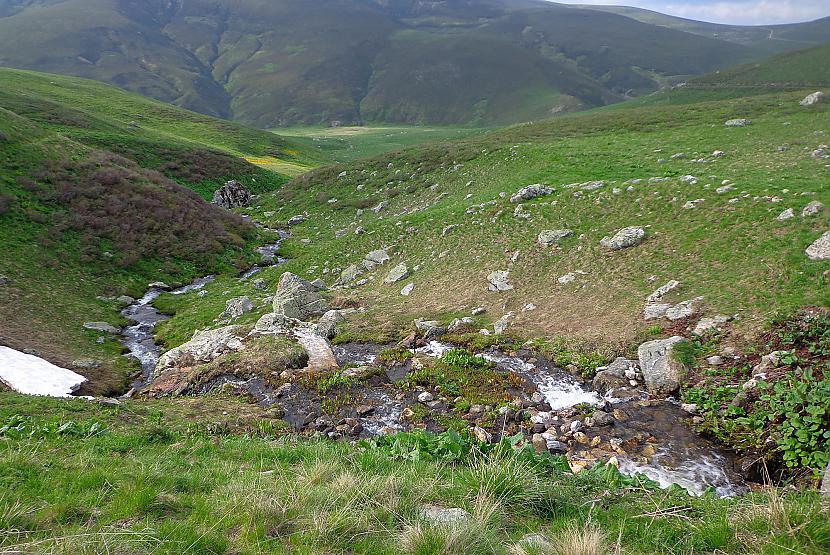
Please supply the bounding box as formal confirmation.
[0,392,830,555]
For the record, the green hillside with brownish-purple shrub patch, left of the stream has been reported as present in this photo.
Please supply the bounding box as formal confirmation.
[0,69,318,392]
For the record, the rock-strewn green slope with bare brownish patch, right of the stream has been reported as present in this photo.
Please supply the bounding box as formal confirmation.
[162,92,830,352]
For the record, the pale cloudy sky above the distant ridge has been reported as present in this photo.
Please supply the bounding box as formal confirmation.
[558,0,830,25]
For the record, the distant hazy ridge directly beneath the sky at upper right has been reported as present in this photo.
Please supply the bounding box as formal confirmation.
[583,5,830,53]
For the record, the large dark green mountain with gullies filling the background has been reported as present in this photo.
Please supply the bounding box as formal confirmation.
[0,0,768,128]
